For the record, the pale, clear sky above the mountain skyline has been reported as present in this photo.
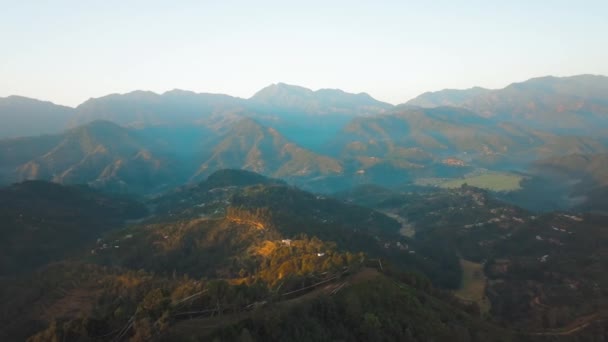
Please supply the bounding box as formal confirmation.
[0,0,608,106]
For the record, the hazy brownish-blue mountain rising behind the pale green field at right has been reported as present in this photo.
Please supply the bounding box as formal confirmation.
[330,107,605,172]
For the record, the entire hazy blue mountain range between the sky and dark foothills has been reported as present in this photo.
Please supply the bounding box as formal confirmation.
[0,75,608,203]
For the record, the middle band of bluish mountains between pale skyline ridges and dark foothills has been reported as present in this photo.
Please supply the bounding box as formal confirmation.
[0,101,606,194]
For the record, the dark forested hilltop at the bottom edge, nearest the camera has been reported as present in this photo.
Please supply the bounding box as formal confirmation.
[207,276,515,341]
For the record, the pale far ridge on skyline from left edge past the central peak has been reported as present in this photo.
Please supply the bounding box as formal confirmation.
[0,83,392,139]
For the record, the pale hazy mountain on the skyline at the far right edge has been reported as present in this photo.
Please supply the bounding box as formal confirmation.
[407,75,608,136]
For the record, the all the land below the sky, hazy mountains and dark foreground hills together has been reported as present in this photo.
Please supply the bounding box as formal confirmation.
[0,76,608,342]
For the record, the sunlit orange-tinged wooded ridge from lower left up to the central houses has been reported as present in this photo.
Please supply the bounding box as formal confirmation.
[23,235,365,341]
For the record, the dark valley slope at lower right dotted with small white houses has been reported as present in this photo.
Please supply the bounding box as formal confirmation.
[341,186,608,332]
